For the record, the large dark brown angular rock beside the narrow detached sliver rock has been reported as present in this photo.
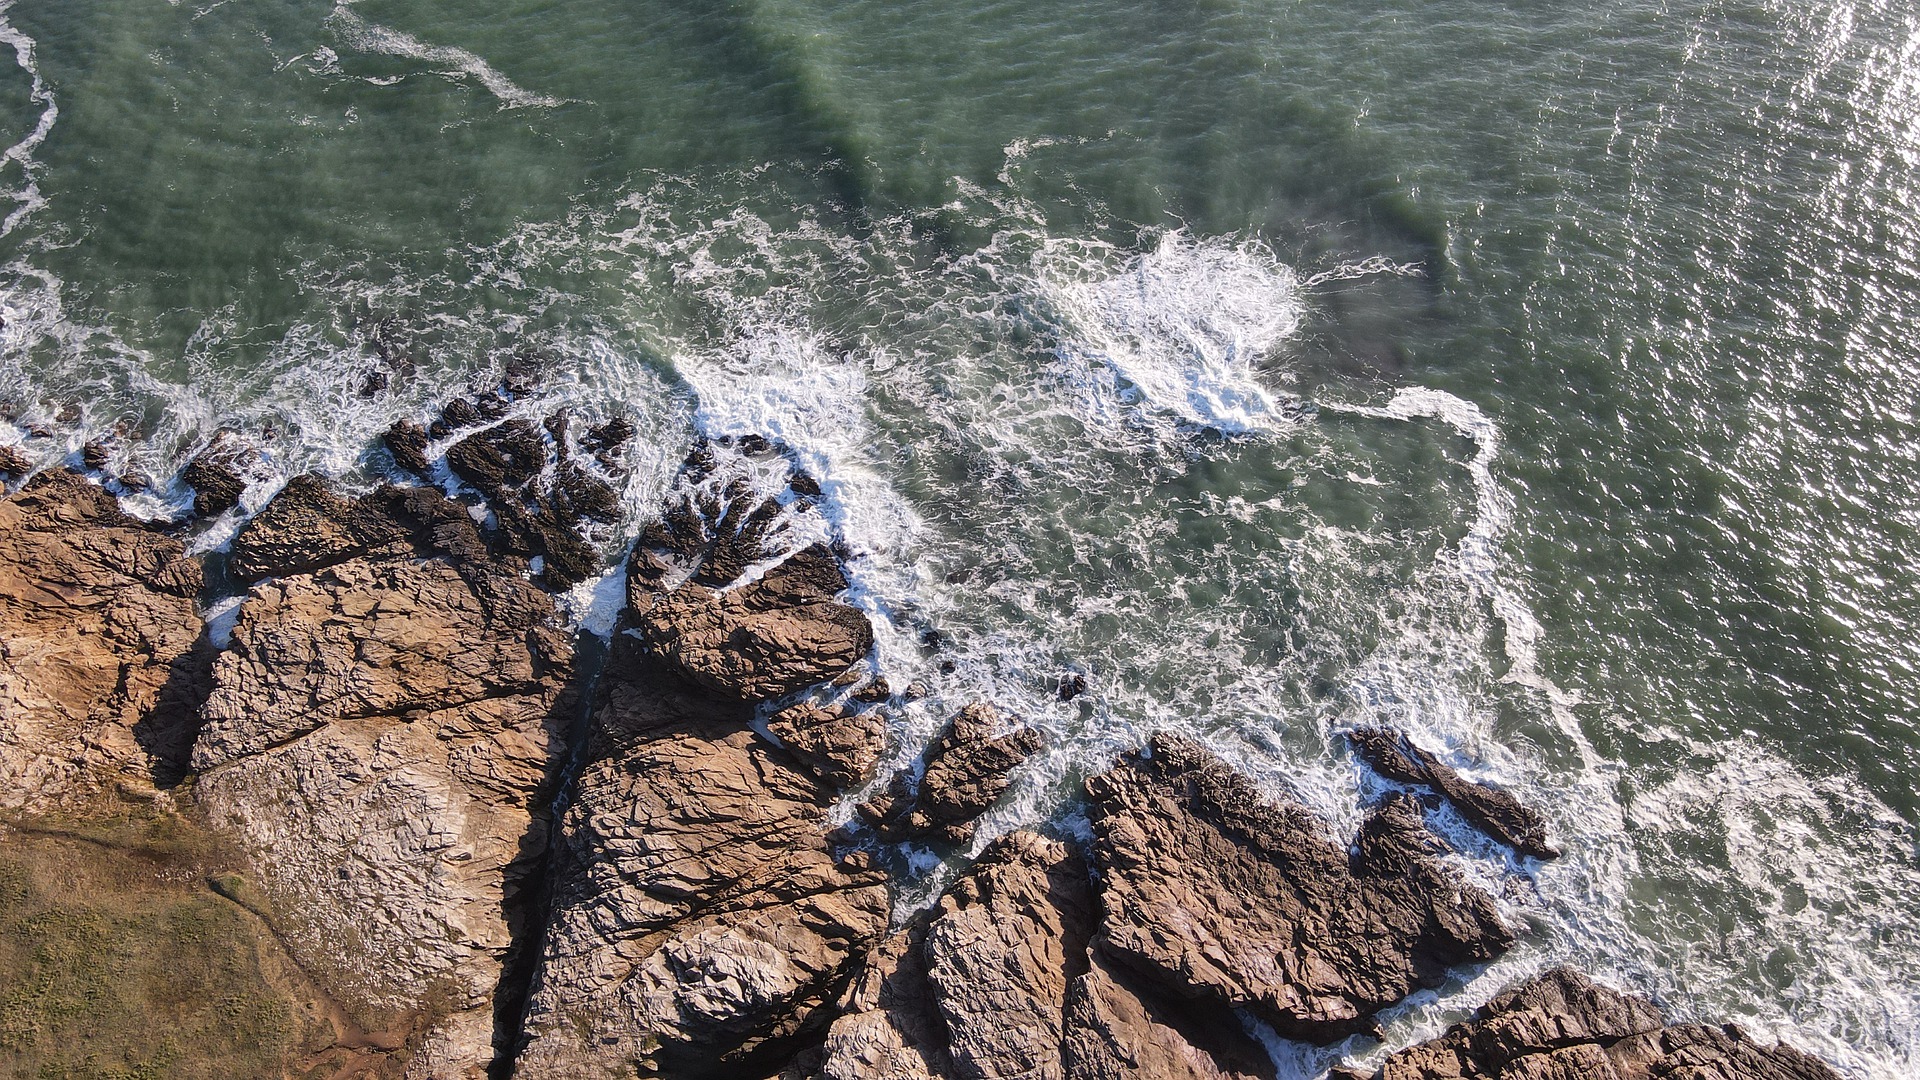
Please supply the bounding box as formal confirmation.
[1087,734,1513,1043]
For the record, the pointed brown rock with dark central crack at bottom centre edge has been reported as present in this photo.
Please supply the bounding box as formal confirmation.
[820,832,1273,1080]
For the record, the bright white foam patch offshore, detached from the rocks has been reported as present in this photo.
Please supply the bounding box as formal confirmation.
[1035,231,1306,434]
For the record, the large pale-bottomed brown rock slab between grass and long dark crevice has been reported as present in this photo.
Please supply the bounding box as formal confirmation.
[194,480,572,1076]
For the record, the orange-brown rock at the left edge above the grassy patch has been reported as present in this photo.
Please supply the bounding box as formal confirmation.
[0,469,209,811]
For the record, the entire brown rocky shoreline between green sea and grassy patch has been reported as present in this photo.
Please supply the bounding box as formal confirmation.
[0,397,1836,1080]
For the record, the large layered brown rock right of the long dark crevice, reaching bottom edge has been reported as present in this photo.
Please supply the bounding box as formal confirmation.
[516,638,887,1080]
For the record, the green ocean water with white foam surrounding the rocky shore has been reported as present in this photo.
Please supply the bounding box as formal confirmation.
[0,0,1920,1080]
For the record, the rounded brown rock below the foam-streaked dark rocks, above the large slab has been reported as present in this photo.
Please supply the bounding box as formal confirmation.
[636,546,874,701]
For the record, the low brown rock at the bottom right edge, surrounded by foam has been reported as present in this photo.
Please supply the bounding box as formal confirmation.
[1334,967,1839,1080]
